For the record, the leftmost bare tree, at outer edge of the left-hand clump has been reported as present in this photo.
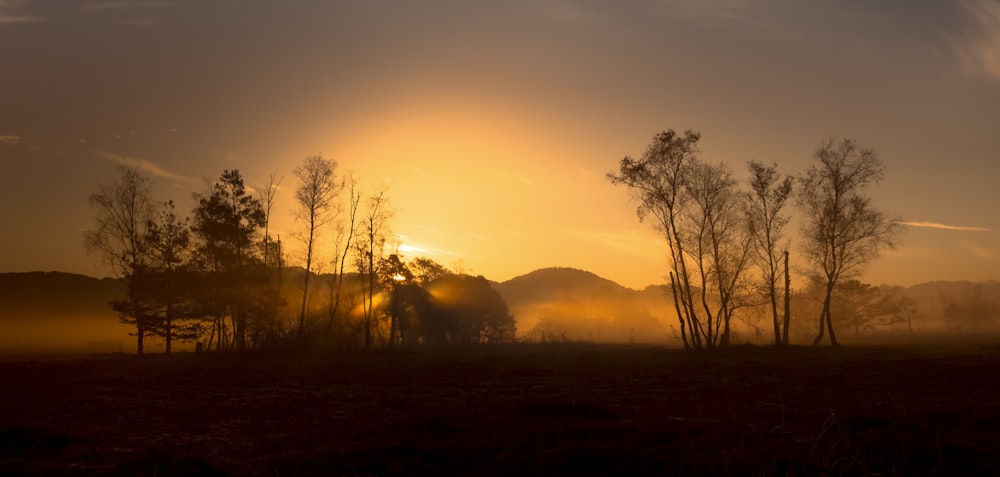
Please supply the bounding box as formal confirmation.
[84,166,153,355]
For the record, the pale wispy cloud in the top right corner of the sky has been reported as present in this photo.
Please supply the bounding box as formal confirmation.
[951,0,1000,81]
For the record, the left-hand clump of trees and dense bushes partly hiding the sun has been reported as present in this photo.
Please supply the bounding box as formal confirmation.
[85,160,516,354]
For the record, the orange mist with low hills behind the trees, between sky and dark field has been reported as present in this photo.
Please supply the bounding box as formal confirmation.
[0,268,1000,354]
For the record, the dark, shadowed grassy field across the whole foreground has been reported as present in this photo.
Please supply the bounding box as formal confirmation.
[0,344,1000,476]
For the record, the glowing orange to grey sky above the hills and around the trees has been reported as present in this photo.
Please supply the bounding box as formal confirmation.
[0,0,1000,288]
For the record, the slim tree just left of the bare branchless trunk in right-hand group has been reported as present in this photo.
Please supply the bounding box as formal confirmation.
[746,161,793,345]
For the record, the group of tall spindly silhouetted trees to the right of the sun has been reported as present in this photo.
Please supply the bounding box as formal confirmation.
[608,130,899,348]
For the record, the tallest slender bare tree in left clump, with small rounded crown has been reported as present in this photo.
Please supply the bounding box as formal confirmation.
[295,156,340,344]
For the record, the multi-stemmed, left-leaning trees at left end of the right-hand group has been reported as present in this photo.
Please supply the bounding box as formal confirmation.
[608,130,750,348]
